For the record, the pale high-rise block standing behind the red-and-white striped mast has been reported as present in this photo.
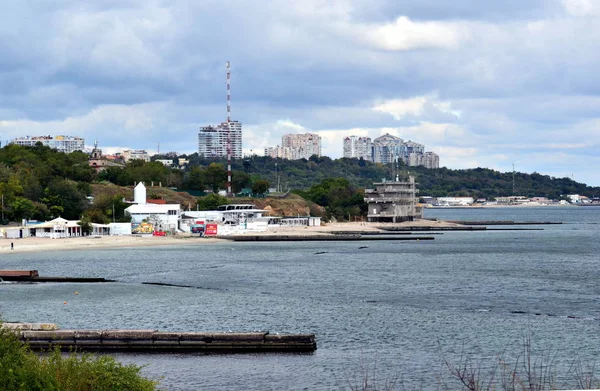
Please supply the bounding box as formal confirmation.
[198,121,242,159]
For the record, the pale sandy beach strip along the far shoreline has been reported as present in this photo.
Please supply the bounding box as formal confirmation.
[0,220,458,254]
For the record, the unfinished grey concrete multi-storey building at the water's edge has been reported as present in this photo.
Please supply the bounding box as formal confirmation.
[365,176,423,223]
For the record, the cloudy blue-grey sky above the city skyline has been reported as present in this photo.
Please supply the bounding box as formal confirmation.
[0,0,600,186]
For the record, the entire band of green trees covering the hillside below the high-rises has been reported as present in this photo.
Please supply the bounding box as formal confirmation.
[0,143,600,223]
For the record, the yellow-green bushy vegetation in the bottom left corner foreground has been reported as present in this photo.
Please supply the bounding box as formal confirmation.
[0,327,157,391]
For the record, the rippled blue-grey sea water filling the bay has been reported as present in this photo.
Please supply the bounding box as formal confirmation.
[0,207,600,390]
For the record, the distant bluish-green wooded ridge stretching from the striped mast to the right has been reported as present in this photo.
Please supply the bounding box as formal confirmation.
[187,154,600,199]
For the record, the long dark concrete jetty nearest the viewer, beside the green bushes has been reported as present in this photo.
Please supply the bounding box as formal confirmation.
[3,323,317,353]
